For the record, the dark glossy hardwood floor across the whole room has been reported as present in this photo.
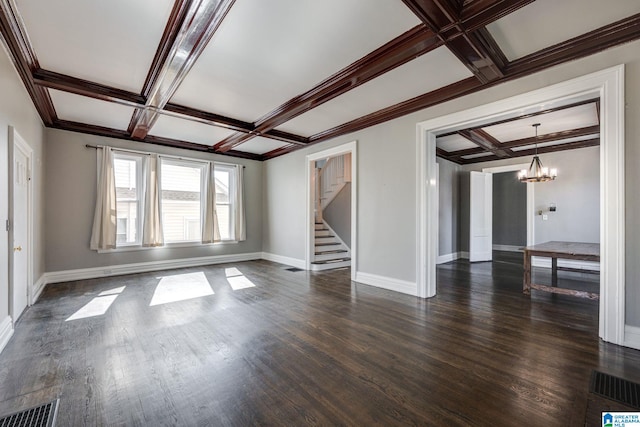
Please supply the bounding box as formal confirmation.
[0,254,640,426]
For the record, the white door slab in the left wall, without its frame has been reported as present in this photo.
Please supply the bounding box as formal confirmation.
[12,134,30,322]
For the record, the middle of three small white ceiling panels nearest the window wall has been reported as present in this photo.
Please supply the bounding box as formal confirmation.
[149,115,234,145]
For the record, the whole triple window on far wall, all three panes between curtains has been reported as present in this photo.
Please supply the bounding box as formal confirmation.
[98,151,244,252]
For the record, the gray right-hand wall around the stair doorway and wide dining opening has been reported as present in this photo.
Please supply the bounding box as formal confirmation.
[263,41,640,326]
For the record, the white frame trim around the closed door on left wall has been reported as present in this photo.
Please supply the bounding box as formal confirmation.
[8,126,33,324]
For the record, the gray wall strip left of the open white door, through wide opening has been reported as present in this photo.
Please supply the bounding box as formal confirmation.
[436,158,460,256]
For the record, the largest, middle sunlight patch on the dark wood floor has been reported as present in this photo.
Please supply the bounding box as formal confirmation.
[149,272,213,306]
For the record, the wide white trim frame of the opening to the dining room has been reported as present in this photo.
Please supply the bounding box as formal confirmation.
[416,64,631,345]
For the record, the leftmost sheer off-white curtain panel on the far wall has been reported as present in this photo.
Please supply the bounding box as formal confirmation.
[89,147,116,251]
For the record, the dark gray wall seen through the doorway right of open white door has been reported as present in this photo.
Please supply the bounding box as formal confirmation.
[493,172,527,246]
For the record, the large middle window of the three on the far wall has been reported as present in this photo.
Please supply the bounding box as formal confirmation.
[160,158,205,243]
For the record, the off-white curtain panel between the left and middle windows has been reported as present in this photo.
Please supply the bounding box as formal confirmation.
[142,154,164,247]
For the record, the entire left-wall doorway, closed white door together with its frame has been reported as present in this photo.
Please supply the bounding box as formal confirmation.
[9,127,33,324]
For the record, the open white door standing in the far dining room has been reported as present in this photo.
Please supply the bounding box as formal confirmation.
[469,172,493,262]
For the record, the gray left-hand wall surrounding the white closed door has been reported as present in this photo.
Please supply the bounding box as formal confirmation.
[0,44,45,321]
